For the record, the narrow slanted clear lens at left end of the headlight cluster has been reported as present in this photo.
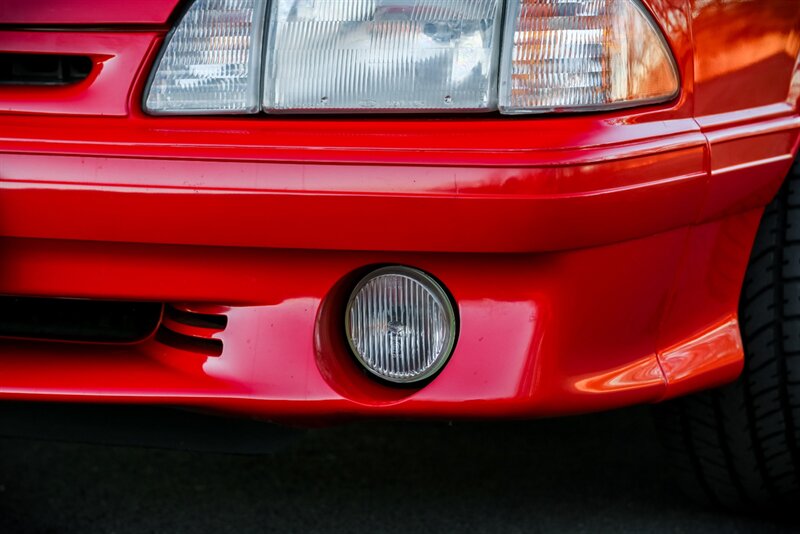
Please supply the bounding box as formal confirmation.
[144,0,266,115]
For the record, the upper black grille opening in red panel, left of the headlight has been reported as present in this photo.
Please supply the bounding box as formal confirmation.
[0,53,92,85]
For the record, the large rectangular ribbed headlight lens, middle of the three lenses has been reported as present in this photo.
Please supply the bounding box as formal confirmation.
[264,0,503,113]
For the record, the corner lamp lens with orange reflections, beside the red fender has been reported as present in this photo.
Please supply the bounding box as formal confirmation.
[499,0,679,114]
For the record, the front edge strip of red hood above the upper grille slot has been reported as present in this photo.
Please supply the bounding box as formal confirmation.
[0,0,180,25]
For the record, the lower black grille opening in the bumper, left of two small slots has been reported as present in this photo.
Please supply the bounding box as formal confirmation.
[0,297,162,343]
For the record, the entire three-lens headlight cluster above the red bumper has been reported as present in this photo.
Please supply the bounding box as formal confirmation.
[144,0,679,114]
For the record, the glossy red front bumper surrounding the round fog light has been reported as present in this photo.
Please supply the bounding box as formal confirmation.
[0,112,797,417]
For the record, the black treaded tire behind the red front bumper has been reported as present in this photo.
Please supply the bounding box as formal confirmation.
[655,158,800,512]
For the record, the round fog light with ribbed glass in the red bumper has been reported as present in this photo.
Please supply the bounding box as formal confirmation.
[345,267,456,383]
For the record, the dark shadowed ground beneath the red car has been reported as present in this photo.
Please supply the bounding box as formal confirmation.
[0,407,800,533]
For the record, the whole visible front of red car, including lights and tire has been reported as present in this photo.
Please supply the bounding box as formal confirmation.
[0,0,800,508]
